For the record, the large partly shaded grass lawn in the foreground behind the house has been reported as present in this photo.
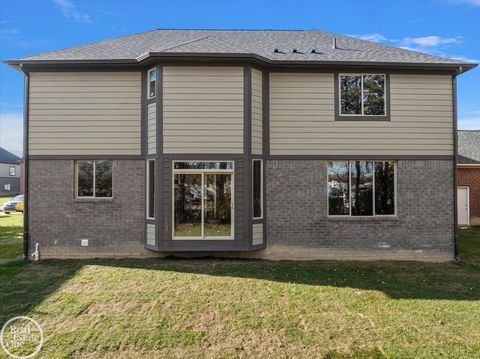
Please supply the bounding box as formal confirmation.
[0,222,480,358]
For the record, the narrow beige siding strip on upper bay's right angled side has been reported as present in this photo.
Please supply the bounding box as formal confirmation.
[252,69,263,155]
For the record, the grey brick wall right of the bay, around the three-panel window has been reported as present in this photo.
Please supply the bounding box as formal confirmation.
[266,160,454,259]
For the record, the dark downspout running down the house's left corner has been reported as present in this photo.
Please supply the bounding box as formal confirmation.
[20,64,30,261]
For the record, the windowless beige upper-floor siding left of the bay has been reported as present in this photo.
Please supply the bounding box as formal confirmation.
[29,72,141,156]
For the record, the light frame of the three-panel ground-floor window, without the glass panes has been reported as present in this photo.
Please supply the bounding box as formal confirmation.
[327,160,397,218]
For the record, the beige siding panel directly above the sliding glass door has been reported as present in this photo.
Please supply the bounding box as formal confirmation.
[163,66,243,154]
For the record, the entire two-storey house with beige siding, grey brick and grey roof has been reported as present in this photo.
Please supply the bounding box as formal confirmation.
[6,30,475,261]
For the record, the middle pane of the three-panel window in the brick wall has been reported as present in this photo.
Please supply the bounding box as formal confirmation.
[350,161,373,216]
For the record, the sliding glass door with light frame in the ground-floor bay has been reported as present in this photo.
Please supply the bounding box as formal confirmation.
[173,162,233,239]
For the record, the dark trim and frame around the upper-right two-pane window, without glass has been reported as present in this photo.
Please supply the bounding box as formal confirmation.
[334,71,391,121]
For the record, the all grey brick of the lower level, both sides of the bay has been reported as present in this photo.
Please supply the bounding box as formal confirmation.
[29,160,454,261]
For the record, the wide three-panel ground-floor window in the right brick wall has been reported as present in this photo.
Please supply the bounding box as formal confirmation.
[328,161,396,216]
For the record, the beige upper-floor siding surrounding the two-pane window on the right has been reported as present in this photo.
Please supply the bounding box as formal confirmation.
[270,73,453,157]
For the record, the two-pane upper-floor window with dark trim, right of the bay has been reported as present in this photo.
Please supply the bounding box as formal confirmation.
[338,74,387,119]
